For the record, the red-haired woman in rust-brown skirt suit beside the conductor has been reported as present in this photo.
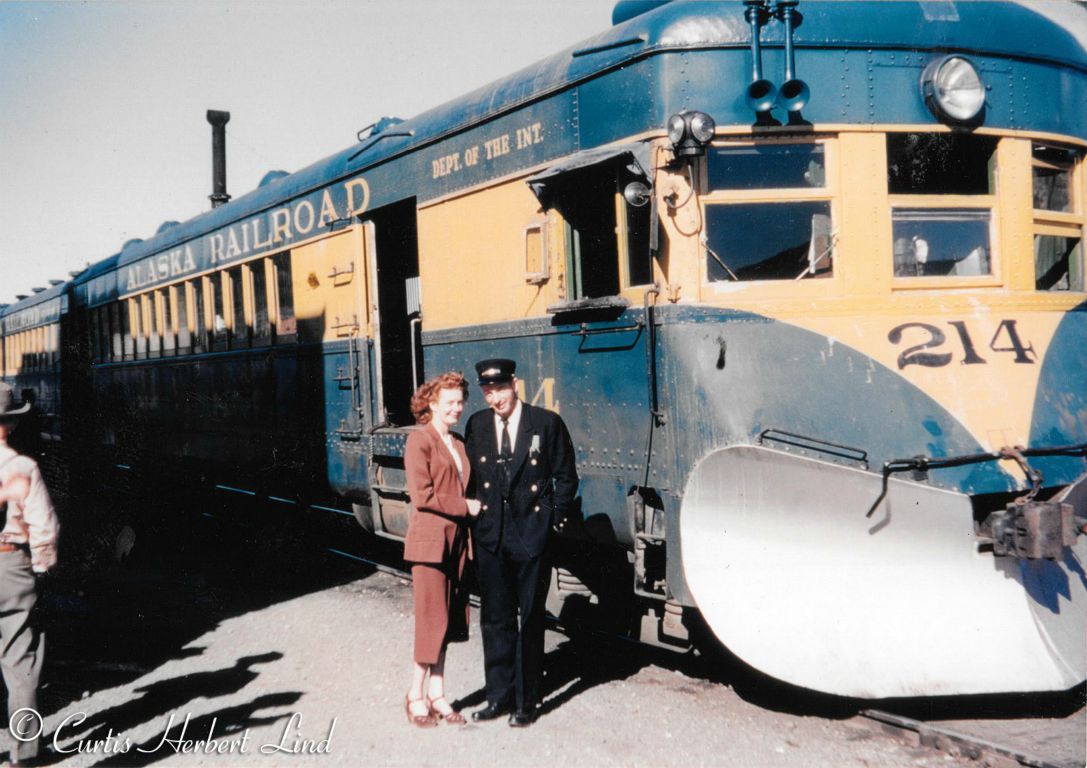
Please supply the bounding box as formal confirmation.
[404,372,479,728]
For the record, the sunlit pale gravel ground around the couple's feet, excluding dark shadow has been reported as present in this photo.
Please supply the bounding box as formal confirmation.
[29,574,973,766]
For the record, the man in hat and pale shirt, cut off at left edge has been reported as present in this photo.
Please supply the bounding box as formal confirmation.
[0,382,59,765]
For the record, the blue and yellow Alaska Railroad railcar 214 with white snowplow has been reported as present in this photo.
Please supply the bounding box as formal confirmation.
[10,0,1087,697]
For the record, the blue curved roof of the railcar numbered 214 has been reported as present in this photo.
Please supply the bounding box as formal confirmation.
[97,0,1087,288]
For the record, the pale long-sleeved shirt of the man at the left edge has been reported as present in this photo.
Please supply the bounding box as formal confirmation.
[0,444,60,574]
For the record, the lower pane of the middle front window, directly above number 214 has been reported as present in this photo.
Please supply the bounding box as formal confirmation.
[891,209,990,277]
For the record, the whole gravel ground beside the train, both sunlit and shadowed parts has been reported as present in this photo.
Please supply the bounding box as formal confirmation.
[0,477,1087,768]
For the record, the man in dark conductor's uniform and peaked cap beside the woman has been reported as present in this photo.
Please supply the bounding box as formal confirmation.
[464,358,577,727]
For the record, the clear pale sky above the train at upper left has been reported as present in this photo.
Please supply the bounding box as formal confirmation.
[0,0,614,304]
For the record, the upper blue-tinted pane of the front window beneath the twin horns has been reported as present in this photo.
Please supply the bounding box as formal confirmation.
[707,144,826,189]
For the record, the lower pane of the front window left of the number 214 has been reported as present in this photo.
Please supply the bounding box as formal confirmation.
[705,200,832,280]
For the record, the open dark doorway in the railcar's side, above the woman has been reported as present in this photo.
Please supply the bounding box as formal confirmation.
[364,198,423,427]
